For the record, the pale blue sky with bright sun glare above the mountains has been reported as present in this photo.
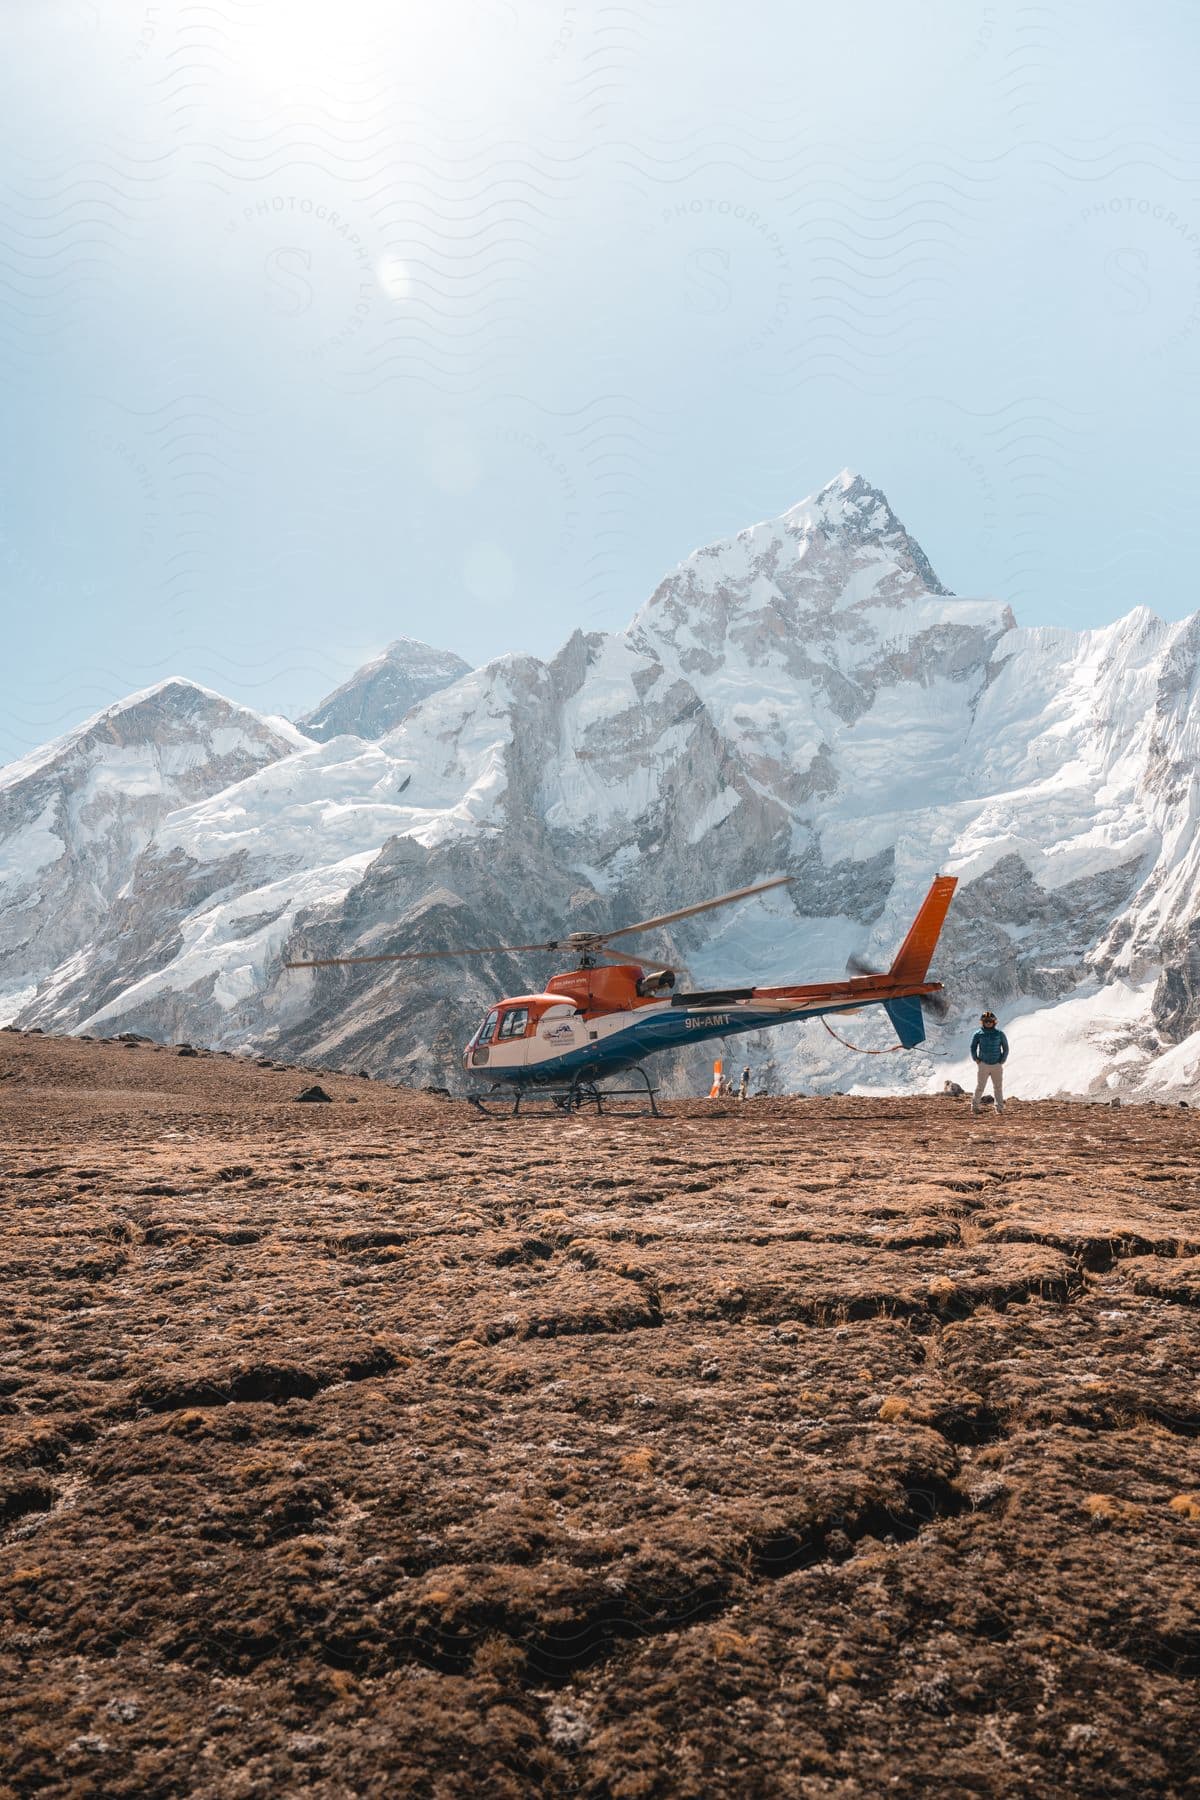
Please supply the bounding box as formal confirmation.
[0,0,1200,761]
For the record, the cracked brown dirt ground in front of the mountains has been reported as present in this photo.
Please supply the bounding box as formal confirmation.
[0,1031,1200,1800]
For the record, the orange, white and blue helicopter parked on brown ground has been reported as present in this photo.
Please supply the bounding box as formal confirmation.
[284,875,957,1112]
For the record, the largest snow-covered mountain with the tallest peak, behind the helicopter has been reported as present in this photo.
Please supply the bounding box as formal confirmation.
[7,472,1200,1093]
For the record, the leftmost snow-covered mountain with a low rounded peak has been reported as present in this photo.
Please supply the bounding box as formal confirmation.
[0,677,304,1017]
